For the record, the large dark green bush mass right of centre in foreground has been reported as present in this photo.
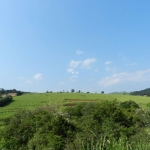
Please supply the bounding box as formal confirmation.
[66,101,142,149]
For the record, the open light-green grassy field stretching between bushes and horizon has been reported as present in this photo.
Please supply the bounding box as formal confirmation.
[0,93,150,118]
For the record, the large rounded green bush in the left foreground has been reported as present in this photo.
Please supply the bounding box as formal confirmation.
[1,108,76,150]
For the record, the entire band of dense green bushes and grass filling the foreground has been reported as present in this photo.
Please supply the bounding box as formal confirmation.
[0,101,150,150]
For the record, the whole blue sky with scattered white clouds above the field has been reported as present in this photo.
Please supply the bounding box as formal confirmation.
[0,0,150,93]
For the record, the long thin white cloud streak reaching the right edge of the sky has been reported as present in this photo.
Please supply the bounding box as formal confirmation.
[99,69,150,86]
